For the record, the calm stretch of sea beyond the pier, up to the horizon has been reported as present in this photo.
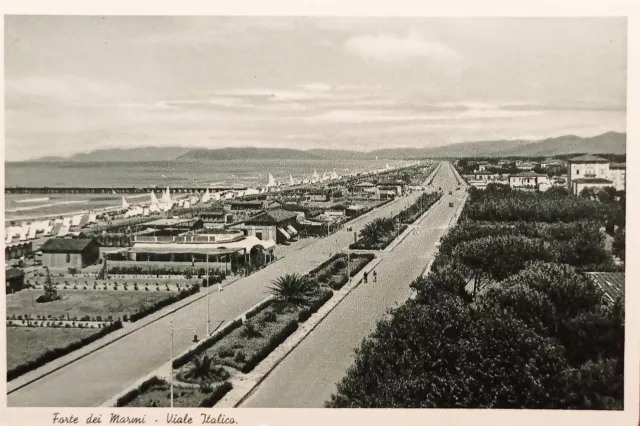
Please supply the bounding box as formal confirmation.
[5,160,405,187]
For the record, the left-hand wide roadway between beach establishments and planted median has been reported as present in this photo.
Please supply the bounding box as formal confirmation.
[7,163,440,407]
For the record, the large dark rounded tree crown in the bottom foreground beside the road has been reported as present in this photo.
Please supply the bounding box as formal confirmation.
[327,295,566,408]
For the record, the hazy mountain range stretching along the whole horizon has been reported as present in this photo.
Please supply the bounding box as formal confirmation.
[25,132,627,162]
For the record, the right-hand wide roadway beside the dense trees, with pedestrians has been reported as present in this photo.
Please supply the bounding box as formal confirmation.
[240,163,464,408]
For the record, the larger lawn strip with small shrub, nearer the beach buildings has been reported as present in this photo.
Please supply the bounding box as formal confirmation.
[7,290,176,318]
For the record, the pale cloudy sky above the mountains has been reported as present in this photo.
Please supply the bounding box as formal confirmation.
[5,16,627,161]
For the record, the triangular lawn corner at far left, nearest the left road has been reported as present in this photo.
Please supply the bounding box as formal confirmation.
[7,327,99,370]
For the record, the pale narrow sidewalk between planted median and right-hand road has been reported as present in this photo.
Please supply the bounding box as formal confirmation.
[215,258,382,408]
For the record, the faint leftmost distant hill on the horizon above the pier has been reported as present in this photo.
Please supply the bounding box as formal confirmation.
[37,146,189,162]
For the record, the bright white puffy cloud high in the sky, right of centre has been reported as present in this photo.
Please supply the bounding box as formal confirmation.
[346,33,460,61]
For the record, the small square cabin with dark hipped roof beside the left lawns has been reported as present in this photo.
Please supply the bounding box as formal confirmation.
[40,238,100,269]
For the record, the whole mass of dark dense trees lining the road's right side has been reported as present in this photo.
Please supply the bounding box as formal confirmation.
[326,181,624,409]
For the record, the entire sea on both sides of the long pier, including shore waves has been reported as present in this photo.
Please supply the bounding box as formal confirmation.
[5,159,406,221]
